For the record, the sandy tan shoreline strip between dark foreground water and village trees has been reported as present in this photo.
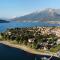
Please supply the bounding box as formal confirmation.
[0,41,59,58]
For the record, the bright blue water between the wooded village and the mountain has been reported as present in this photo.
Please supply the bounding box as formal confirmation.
[0,21,60,32]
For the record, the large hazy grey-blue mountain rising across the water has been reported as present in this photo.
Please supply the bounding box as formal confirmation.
[14,8,60,21]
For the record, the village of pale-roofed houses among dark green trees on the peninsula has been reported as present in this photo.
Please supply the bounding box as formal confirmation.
[0,27,60,56]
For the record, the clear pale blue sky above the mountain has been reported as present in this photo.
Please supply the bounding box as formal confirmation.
[0,0,60,18]
